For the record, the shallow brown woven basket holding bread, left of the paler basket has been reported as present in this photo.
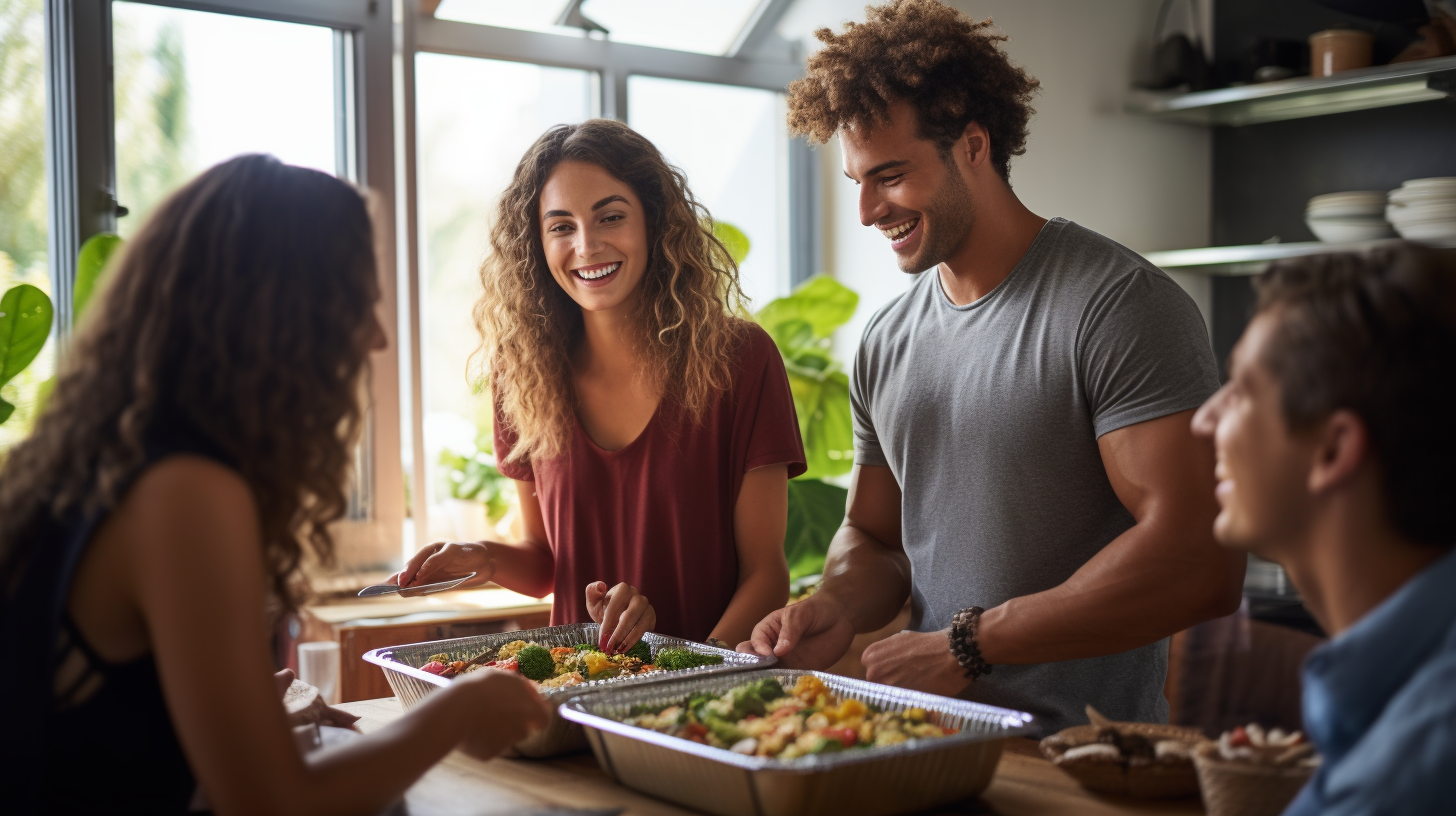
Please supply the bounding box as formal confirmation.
[1041,723,1207,799]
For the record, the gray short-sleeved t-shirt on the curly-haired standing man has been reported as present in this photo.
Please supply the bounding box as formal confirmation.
[850,219,1219,733]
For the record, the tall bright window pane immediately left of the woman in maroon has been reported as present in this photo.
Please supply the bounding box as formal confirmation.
[415,54,597,541]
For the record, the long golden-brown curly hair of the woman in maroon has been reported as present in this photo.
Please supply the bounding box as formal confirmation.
[475,119,745,462]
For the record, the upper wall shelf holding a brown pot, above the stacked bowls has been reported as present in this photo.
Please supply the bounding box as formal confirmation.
[1125,57,1456,127]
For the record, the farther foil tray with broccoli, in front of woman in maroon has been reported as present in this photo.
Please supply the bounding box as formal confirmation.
[364,624,778,756]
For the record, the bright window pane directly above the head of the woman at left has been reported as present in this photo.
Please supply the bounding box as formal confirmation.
[112,1,342,238]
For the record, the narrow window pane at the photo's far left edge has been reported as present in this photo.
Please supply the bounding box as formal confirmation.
[0,0,55,452]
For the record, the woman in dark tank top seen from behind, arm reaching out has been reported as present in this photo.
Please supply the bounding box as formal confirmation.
[0,156,547,815]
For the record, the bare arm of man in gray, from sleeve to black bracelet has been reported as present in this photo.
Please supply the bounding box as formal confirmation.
[977,411,1243,664]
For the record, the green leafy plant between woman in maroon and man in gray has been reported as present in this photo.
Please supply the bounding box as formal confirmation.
[713,221,859,582]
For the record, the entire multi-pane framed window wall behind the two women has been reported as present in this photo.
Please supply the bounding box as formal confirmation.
[31,0,814,567]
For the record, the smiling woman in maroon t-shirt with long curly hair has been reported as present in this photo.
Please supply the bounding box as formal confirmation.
[397,119,804,651]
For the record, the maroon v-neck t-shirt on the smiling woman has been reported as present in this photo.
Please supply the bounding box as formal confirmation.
[495,323,804,641]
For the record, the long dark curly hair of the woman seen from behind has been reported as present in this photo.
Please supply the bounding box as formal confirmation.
[0,156,379,609]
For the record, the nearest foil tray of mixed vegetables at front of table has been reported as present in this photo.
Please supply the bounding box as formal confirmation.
[561,669,1037,816]
